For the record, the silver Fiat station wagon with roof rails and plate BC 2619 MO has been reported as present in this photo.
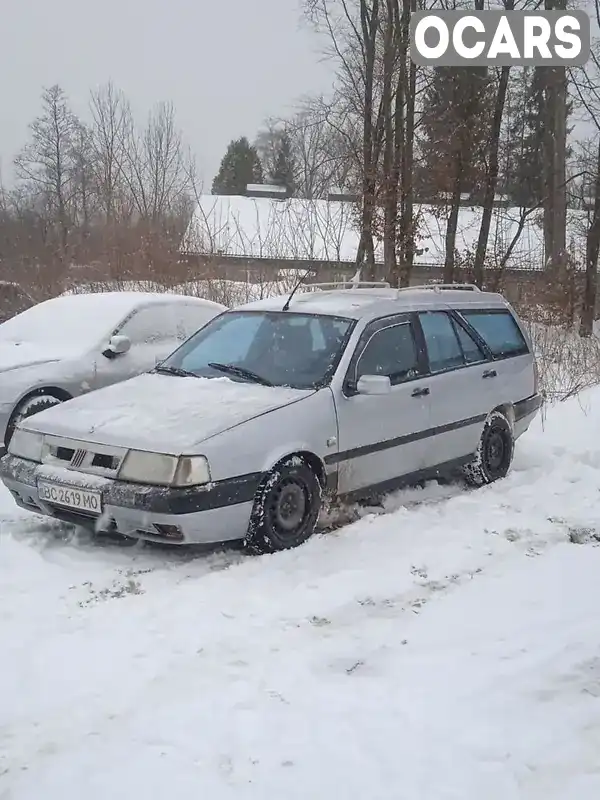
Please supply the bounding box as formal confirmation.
[0,283,541,553]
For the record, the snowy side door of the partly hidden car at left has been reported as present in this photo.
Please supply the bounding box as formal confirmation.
[94,303,180,388]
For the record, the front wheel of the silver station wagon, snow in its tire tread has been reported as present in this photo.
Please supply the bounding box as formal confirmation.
[244,456,322,555]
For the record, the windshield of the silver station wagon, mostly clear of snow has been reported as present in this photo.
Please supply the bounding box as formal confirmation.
[159,311,355,389]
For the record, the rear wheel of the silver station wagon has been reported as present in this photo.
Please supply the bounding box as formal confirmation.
[463,411,515,488]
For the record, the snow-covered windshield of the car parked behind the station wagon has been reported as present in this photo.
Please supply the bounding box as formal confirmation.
[0,294,142,347]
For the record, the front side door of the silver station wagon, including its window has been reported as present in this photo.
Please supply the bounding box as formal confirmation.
[335,314,429,494]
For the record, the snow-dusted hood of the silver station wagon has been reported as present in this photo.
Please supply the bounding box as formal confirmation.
[23,373,314,455]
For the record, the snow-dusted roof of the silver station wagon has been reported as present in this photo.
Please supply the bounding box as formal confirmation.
[236,287,506,319]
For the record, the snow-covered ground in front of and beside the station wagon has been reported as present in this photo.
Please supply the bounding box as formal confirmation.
[0,390,600,800]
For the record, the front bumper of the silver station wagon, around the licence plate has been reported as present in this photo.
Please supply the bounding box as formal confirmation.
[0,455,262,544]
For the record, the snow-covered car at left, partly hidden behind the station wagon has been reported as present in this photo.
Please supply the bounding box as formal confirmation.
[0,292,225,453]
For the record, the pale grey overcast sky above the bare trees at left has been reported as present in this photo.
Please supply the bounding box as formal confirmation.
[0,0,332,188]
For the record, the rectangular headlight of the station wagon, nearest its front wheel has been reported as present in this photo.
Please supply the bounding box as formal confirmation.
[119,450,210,487]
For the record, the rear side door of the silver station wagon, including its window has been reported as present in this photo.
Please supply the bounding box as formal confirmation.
[417,310,497,467]
